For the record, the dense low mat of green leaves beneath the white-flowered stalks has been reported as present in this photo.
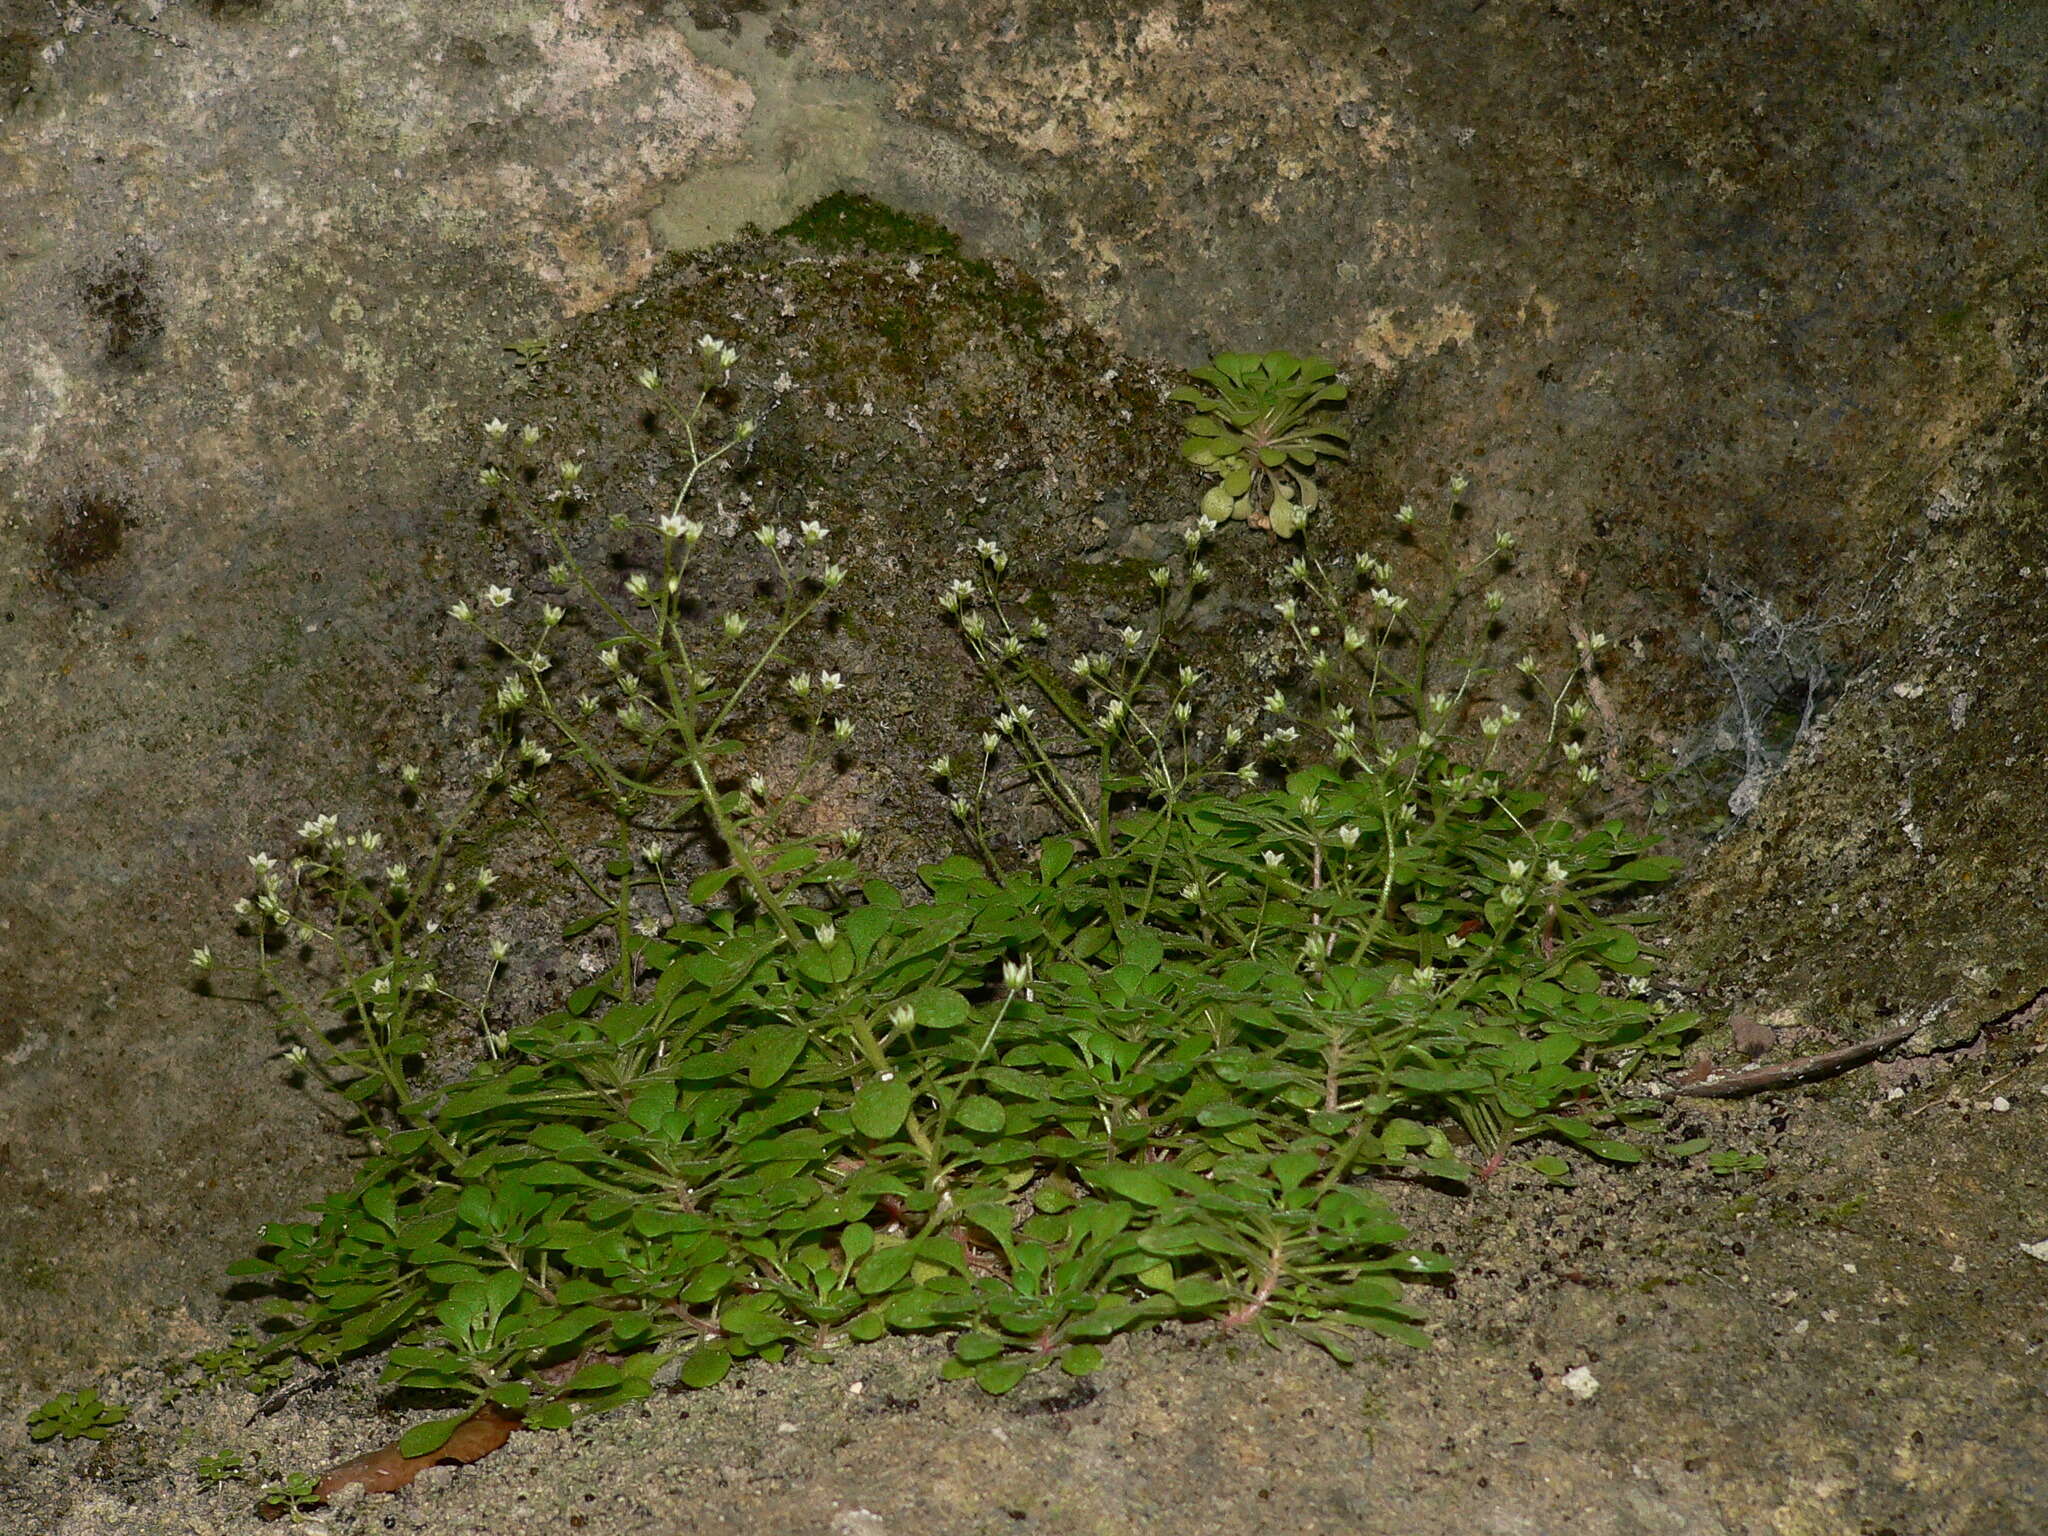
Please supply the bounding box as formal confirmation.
[233,762,1683,1417]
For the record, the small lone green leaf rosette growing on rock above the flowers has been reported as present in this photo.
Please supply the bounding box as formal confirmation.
[1167,352,1350,539]
